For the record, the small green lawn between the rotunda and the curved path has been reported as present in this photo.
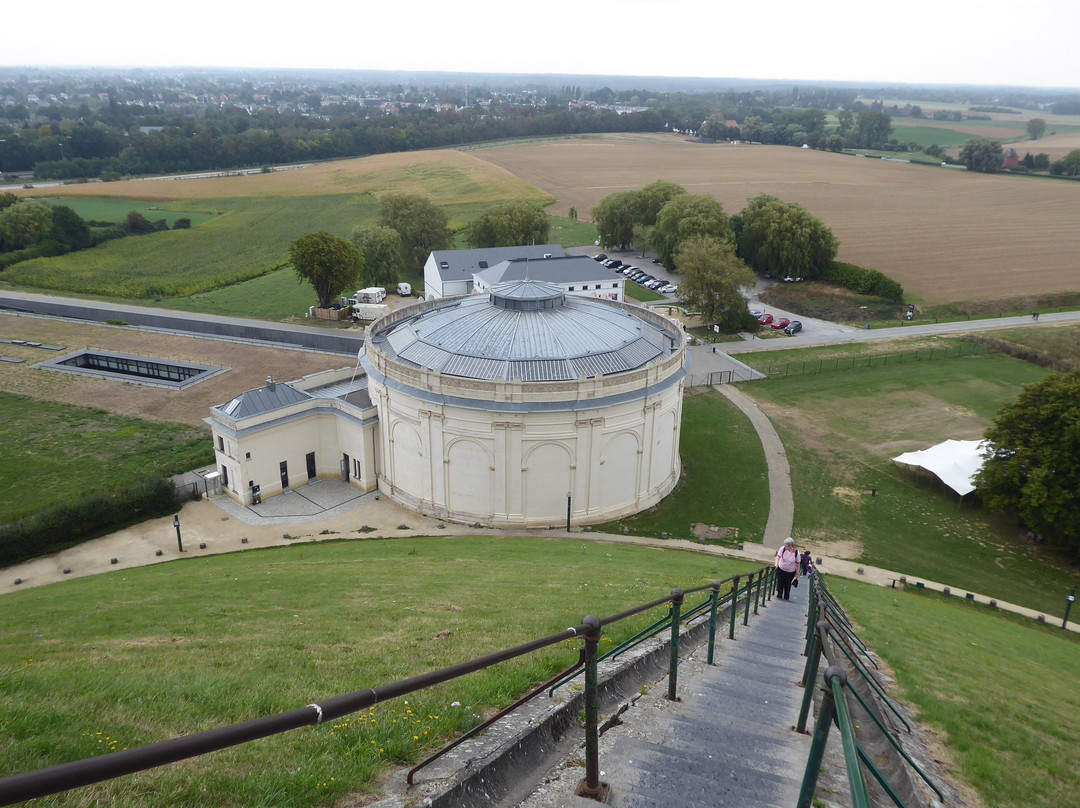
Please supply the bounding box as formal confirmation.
[599,390,769,547]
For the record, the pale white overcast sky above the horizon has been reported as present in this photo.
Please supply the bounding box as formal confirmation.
[8,0,1080,87]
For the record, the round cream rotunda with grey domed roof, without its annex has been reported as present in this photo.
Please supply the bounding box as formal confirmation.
[361,280,688,526]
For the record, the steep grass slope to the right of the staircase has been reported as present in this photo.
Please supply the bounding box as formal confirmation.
[829,577,1080,808]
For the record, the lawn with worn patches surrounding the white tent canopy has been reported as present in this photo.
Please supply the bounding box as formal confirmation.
[741,340,1080,615]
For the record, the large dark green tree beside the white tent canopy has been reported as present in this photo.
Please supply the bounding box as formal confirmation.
[975,372,1080,552]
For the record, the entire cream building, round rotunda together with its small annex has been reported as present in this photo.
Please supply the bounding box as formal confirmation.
[206,278,688,526]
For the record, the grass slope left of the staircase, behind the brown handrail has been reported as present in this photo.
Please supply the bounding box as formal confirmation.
[0,537,755,808]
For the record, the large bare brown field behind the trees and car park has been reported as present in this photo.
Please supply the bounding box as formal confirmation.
[473,136,1080,304]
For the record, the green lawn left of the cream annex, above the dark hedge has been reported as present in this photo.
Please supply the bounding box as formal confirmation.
[0,392,214,522]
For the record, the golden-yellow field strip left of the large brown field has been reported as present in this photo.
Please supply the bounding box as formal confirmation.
[18,150,551,204]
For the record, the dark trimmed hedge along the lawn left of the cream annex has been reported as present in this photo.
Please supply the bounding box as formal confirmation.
[0,476,180,565]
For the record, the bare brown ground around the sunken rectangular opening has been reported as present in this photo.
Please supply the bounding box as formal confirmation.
[0,312,349,427]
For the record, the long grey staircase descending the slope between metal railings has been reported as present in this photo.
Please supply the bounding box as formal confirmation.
[522,579,812,808]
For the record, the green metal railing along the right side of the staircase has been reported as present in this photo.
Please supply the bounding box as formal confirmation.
[795,574,945,808]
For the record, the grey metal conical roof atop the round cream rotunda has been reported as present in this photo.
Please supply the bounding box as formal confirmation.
[369,280,680,381]
